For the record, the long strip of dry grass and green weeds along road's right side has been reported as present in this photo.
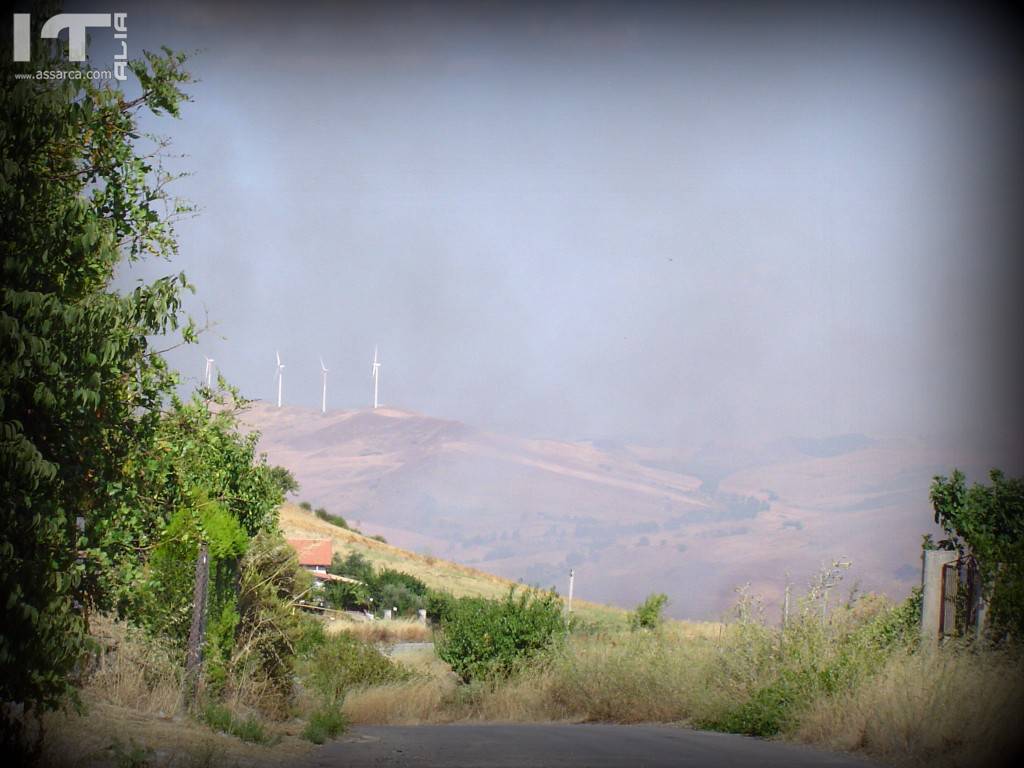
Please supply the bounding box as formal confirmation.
[343,568,1024,766]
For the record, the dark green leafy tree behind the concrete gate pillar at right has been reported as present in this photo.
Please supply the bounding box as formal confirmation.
[931,469,1024,638]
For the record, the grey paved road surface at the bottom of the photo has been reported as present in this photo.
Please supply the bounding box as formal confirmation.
[312,724,873,768]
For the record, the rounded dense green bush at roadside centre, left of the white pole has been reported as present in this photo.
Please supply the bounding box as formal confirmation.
[437,588,565,682]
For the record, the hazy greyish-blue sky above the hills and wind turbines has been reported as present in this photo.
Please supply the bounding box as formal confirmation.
[77,2,1022,450]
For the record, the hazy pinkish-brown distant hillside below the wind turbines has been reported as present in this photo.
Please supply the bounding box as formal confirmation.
[245,403,964,618]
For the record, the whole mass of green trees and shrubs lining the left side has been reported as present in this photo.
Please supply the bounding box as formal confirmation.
[0,13,356,759]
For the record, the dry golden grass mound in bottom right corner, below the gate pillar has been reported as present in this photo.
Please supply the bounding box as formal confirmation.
[796,649,1024,768]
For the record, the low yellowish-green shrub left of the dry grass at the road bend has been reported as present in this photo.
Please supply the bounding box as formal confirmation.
[303,633,409,707]
